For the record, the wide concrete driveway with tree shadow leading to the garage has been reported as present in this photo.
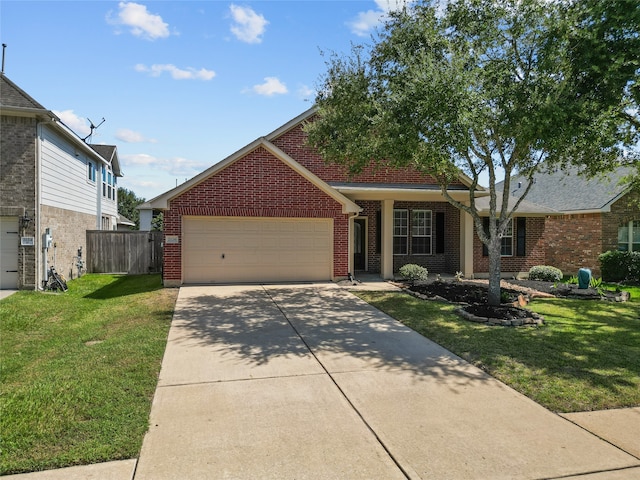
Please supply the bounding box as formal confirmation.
[134,284,640,480]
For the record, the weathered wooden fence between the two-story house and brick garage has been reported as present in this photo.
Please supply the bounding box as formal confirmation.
[86,230,162,275]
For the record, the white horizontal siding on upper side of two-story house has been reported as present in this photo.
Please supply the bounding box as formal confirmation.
[40,126,100,215]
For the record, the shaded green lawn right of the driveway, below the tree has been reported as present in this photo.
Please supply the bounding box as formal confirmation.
[356,288,640,412]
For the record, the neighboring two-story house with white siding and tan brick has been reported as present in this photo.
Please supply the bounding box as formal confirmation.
[0,74,122,289]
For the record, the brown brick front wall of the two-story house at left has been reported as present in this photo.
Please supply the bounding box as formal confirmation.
[0,115,37,289]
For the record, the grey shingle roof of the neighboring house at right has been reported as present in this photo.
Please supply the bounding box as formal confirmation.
[496,167,630,214]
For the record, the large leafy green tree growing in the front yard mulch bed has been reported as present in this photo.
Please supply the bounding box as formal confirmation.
[306,0,639,305]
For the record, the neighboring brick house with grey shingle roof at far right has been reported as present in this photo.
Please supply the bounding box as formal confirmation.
[500,168,640,276]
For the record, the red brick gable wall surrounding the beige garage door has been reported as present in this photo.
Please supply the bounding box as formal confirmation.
[163,147,349,284]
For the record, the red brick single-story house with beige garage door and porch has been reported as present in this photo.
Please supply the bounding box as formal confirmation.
[140,109,558,286]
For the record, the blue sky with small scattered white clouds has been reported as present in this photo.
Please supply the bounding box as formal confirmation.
[0,0,404,199]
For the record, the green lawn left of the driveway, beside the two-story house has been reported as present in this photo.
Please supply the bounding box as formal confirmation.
[0,275,177,475]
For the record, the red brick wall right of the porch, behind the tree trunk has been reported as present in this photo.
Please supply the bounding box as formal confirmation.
[473,217,546,276]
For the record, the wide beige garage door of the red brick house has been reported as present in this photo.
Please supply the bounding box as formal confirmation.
[182,217,333,283]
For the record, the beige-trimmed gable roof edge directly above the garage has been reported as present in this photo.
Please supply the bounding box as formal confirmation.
[138,137,362,213]
